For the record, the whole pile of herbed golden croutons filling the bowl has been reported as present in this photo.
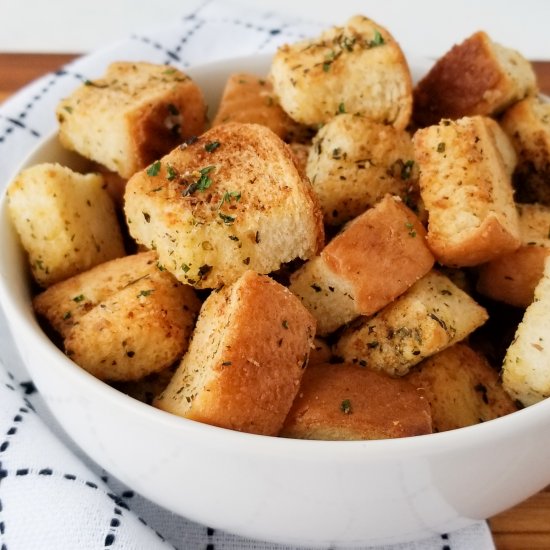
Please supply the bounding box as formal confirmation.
[8,16,550,440]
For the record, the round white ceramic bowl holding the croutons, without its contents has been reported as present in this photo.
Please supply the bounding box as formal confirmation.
[0,56,550,546]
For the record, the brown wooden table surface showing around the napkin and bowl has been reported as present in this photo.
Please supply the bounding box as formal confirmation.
[0,53,550,550]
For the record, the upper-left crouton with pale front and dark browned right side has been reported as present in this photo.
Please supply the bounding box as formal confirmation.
[56,62,206,178]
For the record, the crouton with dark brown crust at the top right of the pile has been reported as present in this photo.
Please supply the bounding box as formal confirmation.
[414,31,537,126]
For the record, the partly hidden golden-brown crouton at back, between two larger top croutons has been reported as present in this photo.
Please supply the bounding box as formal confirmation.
[212,73,307,141]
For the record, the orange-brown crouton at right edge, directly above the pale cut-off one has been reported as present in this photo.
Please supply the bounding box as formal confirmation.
[477,204,550,308]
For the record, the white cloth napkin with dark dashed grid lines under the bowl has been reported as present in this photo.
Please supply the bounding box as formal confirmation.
[0,1,494,550]
